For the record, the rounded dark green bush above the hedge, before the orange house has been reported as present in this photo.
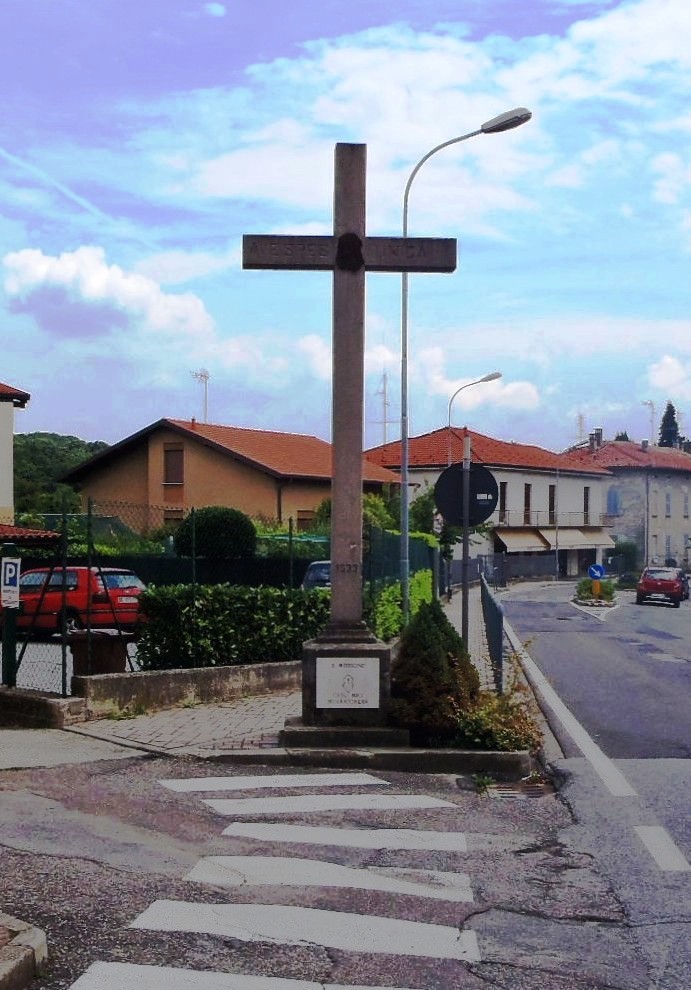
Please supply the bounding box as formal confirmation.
[173,505,257,560]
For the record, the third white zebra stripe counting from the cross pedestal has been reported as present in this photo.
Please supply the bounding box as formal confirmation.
[223,822,468,852]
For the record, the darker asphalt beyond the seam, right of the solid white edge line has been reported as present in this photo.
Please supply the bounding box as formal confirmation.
[501,583,691,759]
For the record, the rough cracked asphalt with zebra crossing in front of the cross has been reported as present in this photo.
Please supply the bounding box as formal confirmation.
[0,758,648,990]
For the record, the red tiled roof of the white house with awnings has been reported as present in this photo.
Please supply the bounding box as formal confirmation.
[366,426,606,474]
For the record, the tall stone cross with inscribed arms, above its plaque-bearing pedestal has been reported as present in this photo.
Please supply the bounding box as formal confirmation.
[242,144,456,641]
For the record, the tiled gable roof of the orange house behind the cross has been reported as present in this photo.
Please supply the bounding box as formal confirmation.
[65,419,400,484]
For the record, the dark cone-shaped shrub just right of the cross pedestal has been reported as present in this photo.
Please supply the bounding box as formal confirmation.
[389,599,479,744]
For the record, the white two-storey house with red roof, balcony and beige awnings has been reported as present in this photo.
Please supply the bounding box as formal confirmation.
[367,427,614,577]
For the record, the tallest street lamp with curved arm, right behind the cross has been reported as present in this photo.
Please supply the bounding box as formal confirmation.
[400,107,532,625]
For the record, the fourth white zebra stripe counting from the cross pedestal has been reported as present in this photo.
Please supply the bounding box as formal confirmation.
[185,856,473,903]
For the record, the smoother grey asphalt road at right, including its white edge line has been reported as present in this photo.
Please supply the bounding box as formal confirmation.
[501,583,691,990]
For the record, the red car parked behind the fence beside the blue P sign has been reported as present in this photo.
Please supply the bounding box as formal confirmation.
[7,567,145,634]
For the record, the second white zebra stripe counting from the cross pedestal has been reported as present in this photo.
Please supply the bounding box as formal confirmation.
[204,794,456,815]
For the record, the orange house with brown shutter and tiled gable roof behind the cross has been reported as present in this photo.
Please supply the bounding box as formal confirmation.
[61,419,399,532]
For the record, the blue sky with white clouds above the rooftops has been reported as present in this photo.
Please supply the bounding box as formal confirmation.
[0,0,691,450]
